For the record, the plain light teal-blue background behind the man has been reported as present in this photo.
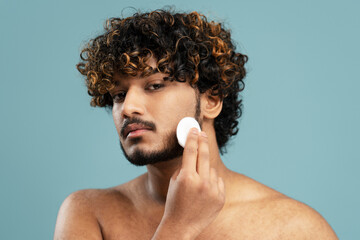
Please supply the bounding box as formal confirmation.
[0,0,360,239]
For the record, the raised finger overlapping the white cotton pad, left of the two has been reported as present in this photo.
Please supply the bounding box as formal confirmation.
[181,128,199,172]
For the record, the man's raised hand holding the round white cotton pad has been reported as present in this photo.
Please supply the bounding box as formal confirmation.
[162,128,225,237]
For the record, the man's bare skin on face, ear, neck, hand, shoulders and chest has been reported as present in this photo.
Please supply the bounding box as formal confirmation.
[54,58,338,240]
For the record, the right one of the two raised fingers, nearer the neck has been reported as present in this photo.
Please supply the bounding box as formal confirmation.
[197,132,210,179]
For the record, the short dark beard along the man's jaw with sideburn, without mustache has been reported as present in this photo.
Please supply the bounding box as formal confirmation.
[119,90,202,166]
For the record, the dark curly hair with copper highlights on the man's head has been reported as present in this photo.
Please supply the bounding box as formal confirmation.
[76,10,248,154]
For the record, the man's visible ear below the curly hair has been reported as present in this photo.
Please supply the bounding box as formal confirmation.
[201,89,223,119]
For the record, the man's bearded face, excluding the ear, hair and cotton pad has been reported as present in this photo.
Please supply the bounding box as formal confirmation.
[110,59,201,166]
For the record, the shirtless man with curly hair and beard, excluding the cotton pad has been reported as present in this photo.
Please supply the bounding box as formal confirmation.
[54,10,337,240]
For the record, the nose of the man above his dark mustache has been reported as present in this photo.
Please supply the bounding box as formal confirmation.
[121,87,145,118]
